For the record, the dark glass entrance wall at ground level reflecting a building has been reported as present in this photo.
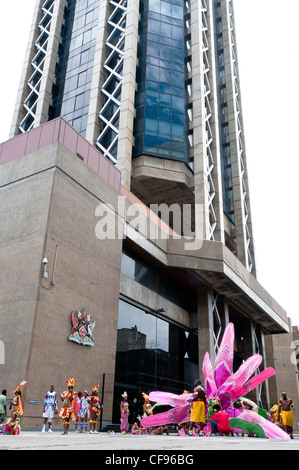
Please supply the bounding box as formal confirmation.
[113,299,198,423]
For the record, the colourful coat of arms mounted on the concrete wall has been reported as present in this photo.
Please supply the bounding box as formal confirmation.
[69,307,96,346]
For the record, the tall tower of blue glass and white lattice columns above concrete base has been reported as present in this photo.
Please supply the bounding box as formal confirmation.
[11,0,255,274]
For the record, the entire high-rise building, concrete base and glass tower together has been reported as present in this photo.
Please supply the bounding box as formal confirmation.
[0,0,298,422]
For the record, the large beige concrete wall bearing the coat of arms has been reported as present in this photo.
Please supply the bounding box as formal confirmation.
[0,143,122,427]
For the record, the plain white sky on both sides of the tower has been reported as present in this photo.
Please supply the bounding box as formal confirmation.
[0,0,299,325]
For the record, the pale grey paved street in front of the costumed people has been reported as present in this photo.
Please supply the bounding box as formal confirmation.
[0,431,299,452]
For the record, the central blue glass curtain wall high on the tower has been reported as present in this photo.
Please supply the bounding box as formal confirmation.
[133,0,189,163]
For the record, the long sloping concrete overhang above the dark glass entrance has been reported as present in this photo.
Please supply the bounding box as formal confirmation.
[121,187,289,334]
